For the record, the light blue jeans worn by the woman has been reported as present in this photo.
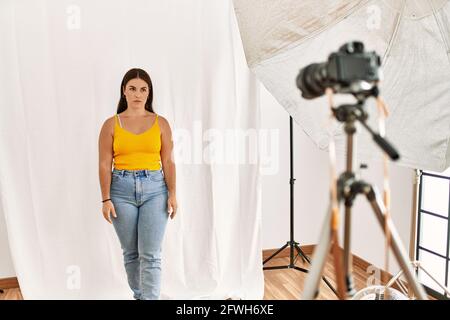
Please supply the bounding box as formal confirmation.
[110,169,169,300]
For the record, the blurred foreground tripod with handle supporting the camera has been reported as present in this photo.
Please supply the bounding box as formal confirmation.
[302,94,427,300]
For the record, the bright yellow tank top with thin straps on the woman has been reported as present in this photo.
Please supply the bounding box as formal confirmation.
[113,115,161,170]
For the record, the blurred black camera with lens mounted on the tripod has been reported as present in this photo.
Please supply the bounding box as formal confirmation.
[297,41,381,99]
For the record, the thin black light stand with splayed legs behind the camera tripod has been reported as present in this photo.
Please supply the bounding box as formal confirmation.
[263,116,337,294]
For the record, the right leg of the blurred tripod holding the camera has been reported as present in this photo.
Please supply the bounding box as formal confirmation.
[364,185,428,300]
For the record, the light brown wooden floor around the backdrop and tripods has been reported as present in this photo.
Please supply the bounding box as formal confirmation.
[0,257,369,300]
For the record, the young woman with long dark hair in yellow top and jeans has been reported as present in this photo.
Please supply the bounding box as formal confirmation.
[99,69,177,300]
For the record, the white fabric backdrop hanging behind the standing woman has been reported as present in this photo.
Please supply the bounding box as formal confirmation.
[0,0,264,299]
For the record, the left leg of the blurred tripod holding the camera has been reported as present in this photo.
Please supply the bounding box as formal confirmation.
[302,204,331,300]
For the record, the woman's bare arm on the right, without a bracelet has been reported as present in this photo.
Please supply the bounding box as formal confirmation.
[159,116,177,219]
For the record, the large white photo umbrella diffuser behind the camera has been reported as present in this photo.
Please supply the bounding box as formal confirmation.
[233,0,450,171]
